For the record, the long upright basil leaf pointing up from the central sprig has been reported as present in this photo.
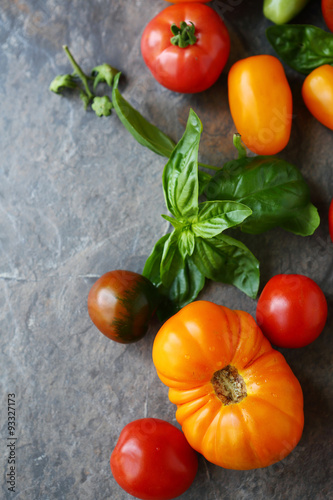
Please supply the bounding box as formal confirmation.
[162,110,202,219]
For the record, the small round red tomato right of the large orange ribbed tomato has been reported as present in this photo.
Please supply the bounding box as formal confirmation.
[256,274,327,347]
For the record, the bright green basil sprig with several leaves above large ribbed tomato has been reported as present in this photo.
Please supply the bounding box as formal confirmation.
[143,110,259,316]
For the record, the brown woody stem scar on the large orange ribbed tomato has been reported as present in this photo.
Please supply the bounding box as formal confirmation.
[211,365,247,406]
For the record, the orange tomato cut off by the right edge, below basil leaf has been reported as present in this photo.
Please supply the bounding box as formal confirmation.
[302,64,333,130]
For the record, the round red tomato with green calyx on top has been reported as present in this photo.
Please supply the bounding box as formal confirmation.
[141,2,230,93]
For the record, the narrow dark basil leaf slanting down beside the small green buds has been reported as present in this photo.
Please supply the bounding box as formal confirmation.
[112,73,175,158]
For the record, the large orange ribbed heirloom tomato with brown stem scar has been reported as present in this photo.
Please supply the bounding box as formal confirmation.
[153,301,304,470]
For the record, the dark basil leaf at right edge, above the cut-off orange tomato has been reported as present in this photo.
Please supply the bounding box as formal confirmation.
[266,24,333,75]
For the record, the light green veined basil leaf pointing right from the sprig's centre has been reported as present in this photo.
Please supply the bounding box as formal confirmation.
[192,201,252,238]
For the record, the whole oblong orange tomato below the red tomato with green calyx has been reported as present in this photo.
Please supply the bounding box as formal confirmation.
[228,55,292,155]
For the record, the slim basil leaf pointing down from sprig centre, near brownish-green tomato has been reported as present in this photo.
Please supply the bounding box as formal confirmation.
[160,231,184,287]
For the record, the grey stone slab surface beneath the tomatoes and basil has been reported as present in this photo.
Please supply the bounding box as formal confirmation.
[0,0,333,500]
